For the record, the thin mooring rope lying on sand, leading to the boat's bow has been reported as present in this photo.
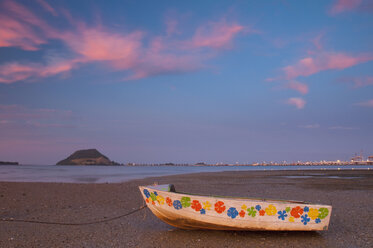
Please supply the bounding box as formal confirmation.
[0,205,146,226]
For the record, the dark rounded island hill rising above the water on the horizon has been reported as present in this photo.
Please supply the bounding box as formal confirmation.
[57,149,119,165]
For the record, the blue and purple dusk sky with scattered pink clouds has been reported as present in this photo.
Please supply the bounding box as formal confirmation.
[0,0,373,164]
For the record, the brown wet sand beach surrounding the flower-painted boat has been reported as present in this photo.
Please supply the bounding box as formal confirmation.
[0,170,373,247]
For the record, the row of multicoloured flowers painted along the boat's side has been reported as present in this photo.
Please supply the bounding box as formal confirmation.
[143,189,329,225]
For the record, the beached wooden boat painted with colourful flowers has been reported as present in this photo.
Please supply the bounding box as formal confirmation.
[139,184,332,231]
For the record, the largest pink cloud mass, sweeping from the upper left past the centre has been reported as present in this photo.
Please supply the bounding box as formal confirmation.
[0,0,248,84]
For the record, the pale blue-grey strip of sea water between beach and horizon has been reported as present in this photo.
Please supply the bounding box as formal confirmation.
[0,165,373,183]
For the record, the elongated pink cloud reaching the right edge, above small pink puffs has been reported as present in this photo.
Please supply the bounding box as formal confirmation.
[283,52,373,80]
